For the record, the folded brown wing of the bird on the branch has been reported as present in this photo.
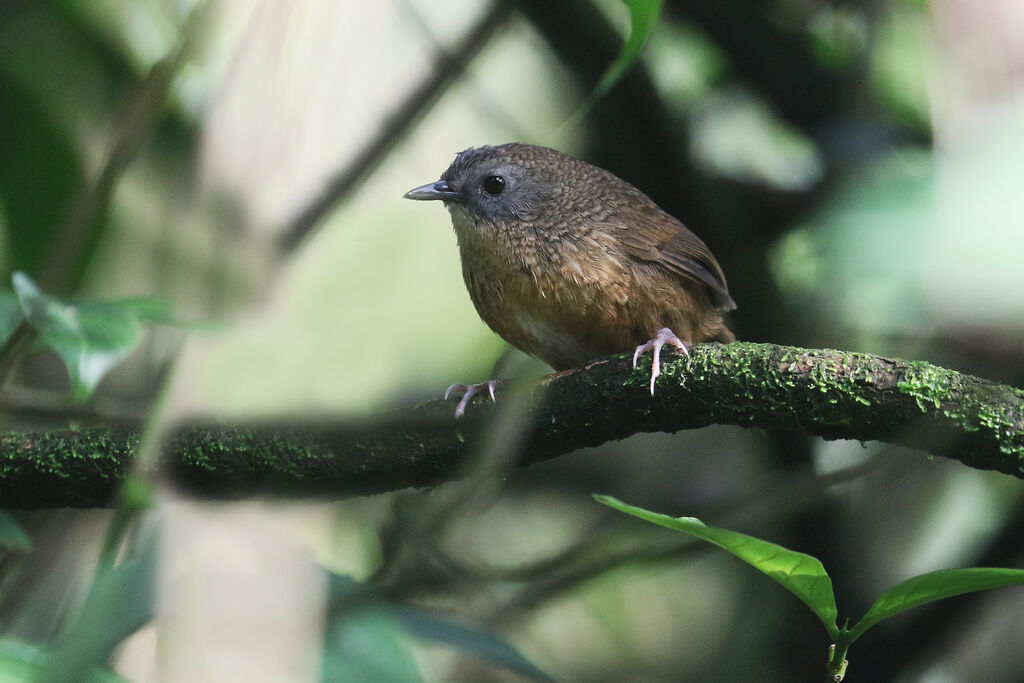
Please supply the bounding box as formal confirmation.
[613,205,736,310]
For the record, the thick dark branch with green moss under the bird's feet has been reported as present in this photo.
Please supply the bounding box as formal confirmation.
[0,343,1024,508]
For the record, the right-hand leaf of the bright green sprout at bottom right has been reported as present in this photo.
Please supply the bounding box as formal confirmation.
[850,567,1024,643]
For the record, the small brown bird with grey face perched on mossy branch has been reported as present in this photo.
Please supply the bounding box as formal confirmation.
[406,142,736,415]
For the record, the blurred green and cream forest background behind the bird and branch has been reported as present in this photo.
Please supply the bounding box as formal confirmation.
[0,0,1024,681]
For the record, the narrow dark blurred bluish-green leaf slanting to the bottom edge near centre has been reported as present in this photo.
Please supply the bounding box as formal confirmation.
[398,607,554,683]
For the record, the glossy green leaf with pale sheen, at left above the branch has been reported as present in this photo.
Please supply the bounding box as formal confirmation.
[13,272,139,400]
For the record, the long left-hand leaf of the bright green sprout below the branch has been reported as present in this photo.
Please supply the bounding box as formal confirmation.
[594,496,839,642]
